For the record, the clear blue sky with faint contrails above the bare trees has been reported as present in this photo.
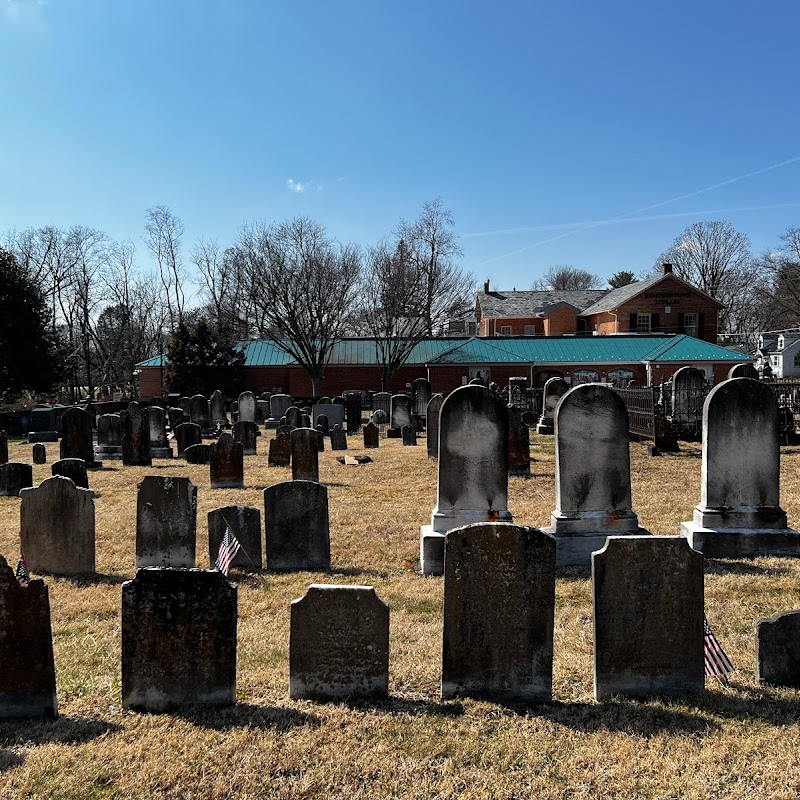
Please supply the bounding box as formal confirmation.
[0,0,800,289]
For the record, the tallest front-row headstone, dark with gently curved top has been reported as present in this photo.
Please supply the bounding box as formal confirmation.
[442,523,556,703]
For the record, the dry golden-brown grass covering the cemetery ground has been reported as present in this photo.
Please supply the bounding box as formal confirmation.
[0,436,800,800]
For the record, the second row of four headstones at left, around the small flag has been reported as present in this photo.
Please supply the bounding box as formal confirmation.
[14,475,330,575]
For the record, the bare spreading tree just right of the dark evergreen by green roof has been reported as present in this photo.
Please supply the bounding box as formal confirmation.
[236,217,361,395]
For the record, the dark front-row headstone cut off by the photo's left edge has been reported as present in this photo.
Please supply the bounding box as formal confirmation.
[0,556,58,719]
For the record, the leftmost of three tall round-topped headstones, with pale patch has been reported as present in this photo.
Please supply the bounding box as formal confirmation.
[420,385,513,575]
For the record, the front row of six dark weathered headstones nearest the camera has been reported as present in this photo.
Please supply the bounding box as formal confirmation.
[6,523,800,717]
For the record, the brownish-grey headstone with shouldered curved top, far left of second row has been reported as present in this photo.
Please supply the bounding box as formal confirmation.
[19,475,95,575]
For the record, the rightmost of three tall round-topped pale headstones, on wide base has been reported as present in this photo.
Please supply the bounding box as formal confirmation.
[681,378,800,558]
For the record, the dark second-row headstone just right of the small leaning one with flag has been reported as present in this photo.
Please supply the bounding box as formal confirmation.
[264,480,331,572]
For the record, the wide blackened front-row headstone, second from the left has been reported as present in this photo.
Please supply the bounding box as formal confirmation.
[122,568,237,712]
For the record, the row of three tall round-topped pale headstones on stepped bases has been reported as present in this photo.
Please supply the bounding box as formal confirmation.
[420,378,800,574]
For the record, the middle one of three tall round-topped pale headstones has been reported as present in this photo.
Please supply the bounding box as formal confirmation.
[543,383,648,566]
